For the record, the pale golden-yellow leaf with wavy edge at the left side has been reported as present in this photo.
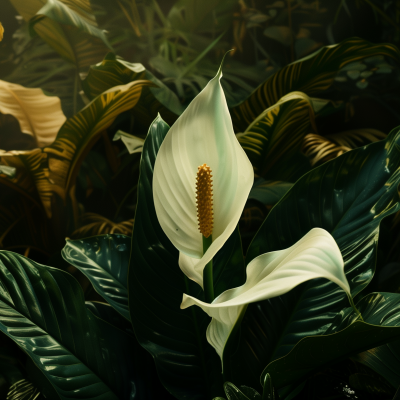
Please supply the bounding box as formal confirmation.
[0,81,66,147]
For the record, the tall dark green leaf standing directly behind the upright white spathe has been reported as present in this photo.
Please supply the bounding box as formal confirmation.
[128,117,244,399]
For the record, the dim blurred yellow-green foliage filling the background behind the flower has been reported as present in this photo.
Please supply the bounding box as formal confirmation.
[0,0,400,399]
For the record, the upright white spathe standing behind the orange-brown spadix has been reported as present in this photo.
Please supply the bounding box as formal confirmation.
[153,64,254,287]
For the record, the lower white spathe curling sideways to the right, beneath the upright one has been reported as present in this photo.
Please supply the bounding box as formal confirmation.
[181,228,351,360]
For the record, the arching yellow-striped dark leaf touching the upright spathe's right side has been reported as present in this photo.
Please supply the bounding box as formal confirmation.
[238,92,317,182]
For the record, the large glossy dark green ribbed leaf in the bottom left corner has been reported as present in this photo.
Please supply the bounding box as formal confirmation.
[0,251,141,400]
